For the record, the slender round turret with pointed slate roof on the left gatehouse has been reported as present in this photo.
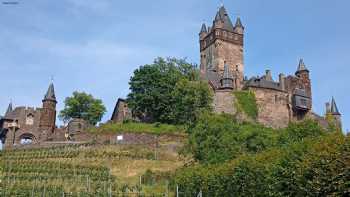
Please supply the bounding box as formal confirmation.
[39,83,57,134]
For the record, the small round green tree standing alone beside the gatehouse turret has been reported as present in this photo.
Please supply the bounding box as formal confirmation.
[59,91,106,125]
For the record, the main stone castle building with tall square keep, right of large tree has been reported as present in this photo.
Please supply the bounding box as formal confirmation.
[199,6,341,128]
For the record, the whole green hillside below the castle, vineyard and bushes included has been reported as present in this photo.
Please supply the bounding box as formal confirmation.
[0,117,350,197]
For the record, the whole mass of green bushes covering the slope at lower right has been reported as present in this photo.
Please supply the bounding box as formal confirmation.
[175,113,350,196]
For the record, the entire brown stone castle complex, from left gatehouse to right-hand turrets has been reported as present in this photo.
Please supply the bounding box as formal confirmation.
[0,6,341,147]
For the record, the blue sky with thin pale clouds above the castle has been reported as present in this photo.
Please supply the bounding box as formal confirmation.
[0,0,350,135]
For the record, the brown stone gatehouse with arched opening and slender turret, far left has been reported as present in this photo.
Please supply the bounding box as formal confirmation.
[0,83,63,147]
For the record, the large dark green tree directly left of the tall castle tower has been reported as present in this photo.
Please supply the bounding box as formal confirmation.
[128,58,211,124]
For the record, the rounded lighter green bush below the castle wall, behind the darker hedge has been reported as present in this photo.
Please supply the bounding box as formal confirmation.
[189,112,278,164]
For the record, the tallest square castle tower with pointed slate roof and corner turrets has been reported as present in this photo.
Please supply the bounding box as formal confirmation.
[199,6,244,89]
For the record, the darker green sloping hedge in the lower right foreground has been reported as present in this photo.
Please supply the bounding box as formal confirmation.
[175,120,350,196]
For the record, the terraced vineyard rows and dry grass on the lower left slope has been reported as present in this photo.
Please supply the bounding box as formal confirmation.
[0,142,183,197]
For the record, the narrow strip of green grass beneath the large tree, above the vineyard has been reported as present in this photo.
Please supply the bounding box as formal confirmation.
[90,122,186,135]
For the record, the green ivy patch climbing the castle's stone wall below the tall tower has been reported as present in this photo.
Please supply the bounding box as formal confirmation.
[234,91,258,120]
